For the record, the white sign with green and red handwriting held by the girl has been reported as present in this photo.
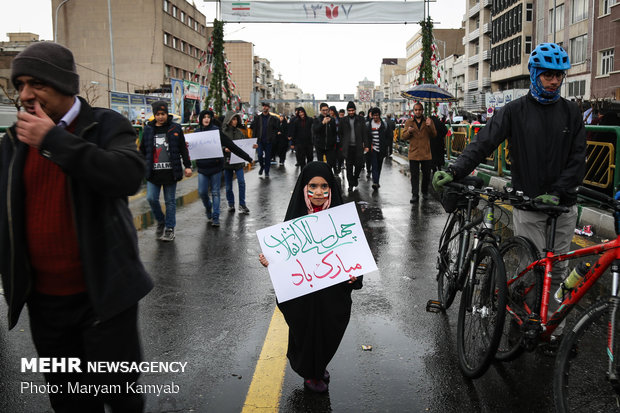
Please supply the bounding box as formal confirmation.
[256,202,377,302]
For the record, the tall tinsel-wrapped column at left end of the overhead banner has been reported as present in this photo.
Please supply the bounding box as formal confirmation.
[207,19,233,114]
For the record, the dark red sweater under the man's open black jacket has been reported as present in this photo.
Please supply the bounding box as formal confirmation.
[24,137,86,295]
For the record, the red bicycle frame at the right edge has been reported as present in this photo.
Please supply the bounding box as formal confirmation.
[506,236,620,339]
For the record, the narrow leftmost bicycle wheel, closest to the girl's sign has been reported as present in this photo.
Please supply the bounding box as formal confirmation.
[437,213,463,310]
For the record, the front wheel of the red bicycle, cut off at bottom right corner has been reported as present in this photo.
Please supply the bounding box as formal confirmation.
[553,301,620,412]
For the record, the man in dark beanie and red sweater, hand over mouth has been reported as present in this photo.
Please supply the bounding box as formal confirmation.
[0,42,153,412]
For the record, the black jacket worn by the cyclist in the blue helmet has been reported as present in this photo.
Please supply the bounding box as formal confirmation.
[451,93,586,205]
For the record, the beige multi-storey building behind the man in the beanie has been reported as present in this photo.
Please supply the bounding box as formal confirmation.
[52,0,211,106]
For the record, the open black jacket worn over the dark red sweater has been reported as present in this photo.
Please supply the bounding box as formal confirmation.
[0,98,153,328]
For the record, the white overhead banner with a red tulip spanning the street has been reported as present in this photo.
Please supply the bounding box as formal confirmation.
[220,0,424,24]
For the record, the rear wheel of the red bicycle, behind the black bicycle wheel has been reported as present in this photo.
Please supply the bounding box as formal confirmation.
[495,237,543,361]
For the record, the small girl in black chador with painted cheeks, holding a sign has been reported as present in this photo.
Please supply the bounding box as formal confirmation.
[259,162,363,393]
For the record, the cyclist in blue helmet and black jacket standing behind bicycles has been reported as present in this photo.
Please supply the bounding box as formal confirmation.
[432,43,586,342]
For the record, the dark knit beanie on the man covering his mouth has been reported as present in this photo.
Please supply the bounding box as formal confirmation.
[11,42,80,96]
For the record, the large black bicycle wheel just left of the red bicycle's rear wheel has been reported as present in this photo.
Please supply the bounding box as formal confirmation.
[456,245,506,379]
